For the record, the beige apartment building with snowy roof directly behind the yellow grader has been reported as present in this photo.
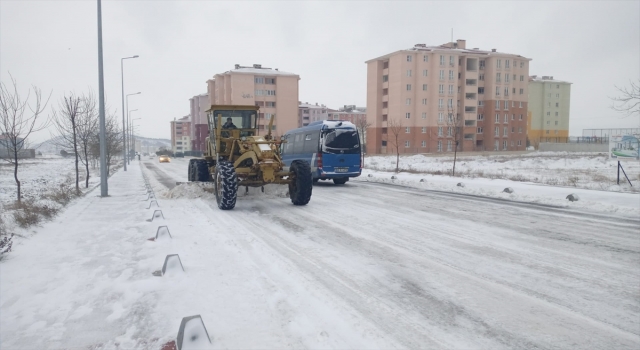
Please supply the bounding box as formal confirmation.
[207,64,300,136]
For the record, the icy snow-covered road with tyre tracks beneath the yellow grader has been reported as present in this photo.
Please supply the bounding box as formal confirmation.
[144,160,640,349]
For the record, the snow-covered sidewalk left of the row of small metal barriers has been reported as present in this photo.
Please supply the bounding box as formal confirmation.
[0,162,179,349]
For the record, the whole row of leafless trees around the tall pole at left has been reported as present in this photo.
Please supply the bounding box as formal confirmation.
[0,77,122,201]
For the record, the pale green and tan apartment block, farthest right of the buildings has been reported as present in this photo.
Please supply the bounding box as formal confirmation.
[527,75,571,148]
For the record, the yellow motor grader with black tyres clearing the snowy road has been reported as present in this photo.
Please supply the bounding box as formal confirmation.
[188,105,313,210]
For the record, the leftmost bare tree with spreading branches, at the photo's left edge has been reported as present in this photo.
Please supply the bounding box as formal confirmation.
[0,75,51,202]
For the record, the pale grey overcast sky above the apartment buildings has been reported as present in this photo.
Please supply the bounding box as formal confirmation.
[0,0,640,141]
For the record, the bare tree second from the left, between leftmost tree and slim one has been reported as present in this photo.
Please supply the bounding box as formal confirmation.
[52,93,82,192]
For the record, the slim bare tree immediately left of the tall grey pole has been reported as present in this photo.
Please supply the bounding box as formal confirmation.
[76,92,100,188]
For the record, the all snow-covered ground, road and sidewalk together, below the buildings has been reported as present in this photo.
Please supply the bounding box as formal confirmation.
[0,156,640,349]
